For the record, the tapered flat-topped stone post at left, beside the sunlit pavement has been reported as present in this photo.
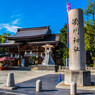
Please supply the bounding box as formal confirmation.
[6,73,15,87]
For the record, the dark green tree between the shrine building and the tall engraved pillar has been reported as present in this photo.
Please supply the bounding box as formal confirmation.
[56,24,68,65]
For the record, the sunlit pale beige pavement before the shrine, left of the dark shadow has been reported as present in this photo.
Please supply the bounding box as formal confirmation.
[0,70,58,84]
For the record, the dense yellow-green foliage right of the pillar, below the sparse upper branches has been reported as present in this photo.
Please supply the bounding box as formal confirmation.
[84,22,95,51]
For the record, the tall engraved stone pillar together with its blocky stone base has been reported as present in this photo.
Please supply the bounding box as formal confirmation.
[64,9,91,86]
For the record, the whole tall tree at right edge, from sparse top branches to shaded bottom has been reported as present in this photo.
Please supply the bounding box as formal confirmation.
[84,0,95,64]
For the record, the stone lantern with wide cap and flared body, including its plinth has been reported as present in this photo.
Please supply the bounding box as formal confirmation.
[38,44,58,72]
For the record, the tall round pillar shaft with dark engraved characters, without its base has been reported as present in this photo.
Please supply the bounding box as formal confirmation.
[69,9,86,70]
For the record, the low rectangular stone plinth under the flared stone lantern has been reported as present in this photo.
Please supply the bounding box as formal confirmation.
[38,65,58,72]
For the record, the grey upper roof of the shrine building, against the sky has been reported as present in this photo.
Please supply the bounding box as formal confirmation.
[8,26,51,39]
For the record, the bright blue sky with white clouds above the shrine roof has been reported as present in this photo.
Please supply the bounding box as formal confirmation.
[0,0,87,34]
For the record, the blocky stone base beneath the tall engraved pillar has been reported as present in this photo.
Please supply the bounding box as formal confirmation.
[64,70,91,86]
